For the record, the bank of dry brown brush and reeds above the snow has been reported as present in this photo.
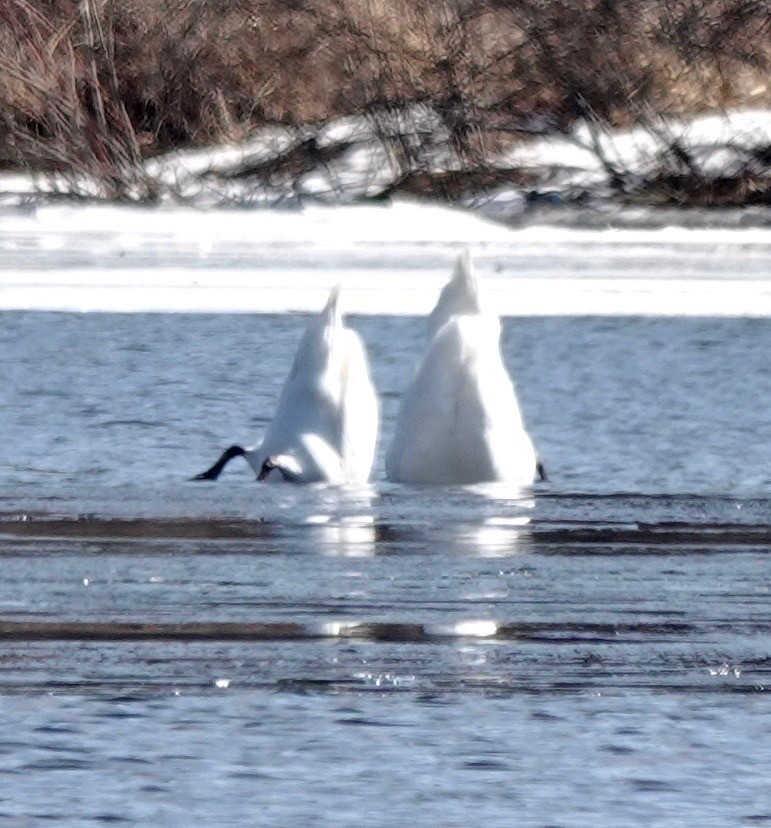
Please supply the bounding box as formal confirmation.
[0,0,771,204]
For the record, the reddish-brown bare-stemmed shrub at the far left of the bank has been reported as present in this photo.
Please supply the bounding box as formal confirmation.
[0,0,153,198]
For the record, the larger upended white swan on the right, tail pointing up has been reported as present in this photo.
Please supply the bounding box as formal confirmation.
[386,252,545,485]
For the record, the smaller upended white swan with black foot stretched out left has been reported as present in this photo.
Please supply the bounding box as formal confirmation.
[193,288,378,485]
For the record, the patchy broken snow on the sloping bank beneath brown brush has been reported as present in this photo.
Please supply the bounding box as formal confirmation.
[0,106,771,209]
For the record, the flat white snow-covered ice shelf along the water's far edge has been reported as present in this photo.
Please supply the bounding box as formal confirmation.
[0,201,771,317]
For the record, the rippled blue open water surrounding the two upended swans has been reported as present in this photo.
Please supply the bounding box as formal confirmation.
[0,312,771,826]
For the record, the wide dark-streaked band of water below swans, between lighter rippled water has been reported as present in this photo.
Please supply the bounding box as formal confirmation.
[0,488,771,695]
